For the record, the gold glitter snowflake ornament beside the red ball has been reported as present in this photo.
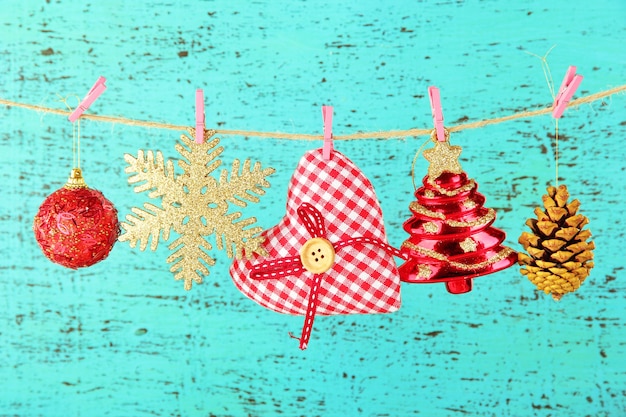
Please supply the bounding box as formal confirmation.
[119,129,275,290]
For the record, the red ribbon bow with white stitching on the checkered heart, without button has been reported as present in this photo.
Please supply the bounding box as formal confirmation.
[250,203,406,350]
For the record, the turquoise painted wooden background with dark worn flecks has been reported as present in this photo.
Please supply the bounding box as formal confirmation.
[0,0,626,416]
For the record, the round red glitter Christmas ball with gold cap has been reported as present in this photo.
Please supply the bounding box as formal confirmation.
[33,169,119,269]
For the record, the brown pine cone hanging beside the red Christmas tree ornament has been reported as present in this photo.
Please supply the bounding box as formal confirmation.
[518,185,595,301]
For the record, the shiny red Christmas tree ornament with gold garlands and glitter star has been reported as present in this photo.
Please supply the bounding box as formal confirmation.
[398,131,517,294]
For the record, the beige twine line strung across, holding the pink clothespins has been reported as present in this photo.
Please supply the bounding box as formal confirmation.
[0,84,626,140]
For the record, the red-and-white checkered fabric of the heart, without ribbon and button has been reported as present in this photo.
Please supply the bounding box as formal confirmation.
[230,149,400,315]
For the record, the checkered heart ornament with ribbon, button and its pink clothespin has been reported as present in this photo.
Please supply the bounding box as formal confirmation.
[230,106,400,349]
